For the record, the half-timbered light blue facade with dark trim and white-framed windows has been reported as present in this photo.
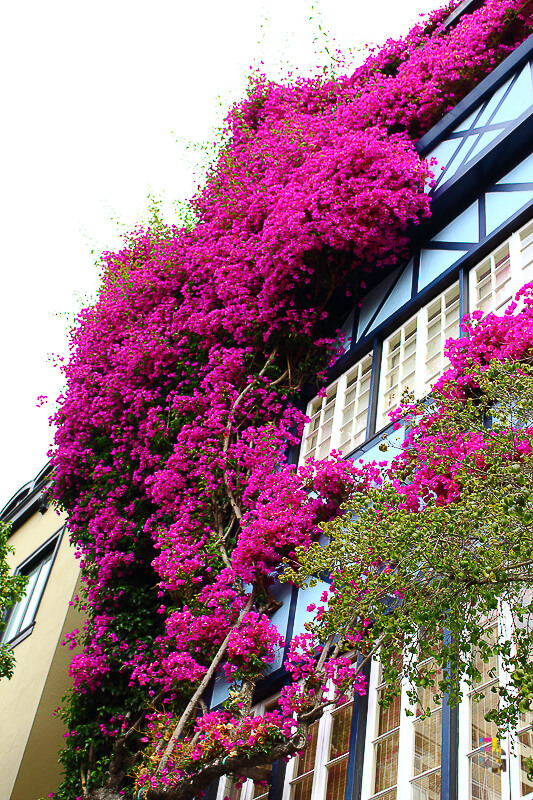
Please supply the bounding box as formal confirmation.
[211,14,533,800]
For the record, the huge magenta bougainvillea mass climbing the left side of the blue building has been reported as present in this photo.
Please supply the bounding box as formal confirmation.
[45,0,533,800]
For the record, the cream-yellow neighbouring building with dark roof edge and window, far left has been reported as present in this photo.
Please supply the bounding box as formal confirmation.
[0,466,82,800]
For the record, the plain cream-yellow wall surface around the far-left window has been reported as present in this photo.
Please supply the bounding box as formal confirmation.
[0,508,83,800]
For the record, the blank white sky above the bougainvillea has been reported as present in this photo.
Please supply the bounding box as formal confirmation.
[0,0,442,507]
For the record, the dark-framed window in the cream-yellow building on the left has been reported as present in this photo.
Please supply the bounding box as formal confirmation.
[2,534,61,643]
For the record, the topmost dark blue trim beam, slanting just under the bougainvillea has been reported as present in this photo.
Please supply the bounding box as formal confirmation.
[416,34,533,158]
